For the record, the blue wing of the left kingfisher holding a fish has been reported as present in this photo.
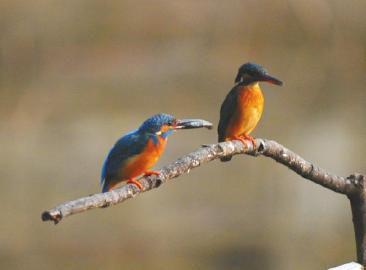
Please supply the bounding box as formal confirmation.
[100,130,146,185]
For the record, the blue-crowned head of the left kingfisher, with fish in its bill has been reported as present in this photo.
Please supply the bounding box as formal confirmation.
[139,113,212,138]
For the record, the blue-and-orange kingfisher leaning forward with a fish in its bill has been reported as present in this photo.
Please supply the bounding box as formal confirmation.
[100,113,212,192]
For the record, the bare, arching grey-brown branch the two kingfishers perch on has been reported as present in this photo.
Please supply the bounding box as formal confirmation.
[42,139,360,224]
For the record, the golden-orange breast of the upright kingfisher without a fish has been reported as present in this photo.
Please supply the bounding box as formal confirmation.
[226,83,264,139]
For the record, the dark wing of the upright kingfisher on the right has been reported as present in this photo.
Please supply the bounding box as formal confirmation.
[217,86,238,142]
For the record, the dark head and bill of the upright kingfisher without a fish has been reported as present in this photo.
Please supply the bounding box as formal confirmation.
[235,62,282,85]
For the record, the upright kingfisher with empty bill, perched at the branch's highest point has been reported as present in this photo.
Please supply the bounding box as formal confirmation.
[217,62,282,161]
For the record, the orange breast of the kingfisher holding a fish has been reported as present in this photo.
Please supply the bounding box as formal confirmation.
[121,136,167,180]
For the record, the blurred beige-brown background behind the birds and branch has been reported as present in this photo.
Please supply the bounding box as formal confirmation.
[0,0,366,270]
